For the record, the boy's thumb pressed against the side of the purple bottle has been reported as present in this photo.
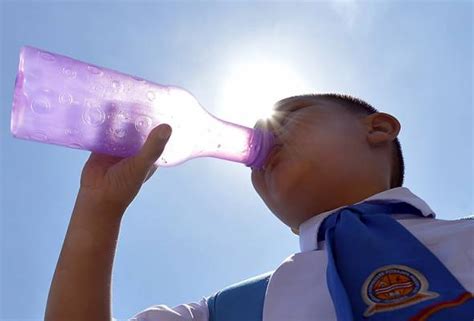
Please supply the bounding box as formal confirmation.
[135,124,172,172]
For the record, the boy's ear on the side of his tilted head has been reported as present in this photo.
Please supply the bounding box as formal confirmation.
[365,113,401,146]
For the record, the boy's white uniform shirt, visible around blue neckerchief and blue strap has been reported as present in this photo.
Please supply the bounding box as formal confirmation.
[130,187,474,321]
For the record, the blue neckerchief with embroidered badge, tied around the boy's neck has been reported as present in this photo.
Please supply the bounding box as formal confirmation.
[318,201,474,321]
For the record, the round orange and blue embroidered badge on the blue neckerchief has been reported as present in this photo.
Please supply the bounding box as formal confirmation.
[362,265,439,317]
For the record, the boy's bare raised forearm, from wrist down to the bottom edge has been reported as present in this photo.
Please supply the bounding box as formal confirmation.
[45,192,124,321]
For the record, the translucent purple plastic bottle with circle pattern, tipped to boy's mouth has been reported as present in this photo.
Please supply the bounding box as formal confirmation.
[11,46,274,168]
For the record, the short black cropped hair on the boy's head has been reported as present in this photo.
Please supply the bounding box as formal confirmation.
[284,93,405,188]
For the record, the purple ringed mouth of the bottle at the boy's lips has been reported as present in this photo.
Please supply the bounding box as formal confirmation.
[245,128,275,170]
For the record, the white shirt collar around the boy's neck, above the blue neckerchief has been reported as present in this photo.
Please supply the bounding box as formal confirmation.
[299,187,435,252]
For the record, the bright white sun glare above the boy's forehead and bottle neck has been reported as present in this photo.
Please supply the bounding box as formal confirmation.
[218,60,308,127]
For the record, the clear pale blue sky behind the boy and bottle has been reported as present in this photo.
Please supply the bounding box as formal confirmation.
[0,1,474,321]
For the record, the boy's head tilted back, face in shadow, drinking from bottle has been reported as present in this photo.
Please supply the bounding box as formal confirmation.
[252,94,404,231]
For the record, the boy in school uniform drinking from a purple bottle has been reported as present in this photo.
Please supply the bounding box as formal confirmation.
[46,94,474,321]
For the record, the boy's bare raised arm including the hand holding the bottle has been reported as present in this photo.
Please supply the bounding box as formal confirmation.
[45,125,171,321]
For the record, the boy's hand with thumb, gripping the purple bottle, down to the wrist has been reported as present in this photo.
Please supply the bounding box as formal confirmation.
[80,124,171,210]
